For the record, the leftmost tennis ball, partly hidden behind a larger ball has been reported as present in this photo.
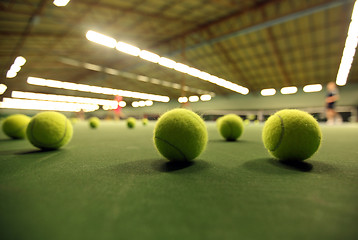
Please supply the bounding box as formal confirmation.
[2,114,31,139]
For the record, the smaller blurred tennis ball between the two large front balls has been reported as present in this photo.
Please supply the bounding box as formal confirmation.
[219,114,244,141]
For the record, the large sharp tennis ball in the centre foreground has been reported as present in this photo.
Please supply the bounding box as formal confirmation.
[153,108,208,161]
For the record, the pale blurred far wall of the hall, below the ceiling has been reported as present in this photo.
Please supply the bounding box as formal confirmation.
[0,84,358,118]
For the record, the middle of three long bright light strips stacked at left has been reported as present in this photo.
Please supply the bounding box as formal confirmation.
[11,91,125,108]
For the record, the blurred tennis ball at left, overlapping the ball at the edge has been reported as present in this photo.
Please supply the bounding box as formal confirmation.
[26,112,73,149]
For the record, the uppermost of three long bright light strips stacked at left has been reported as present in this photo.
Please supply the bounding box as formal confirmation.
[27,77,170,102]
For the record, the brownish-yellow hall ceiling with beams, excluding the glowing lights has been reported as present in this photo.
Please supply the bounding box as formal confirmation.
[0,0,358,102]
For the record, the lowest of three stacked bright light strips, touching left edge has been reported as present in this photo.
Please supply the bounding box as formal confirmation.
[1,98,99,112]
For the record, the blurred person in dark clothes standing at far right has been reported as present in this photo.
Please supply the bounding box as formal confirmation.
[326,82,342,125]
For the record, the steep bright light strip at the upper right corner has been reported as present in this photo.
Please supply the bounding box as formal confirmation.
[336,1,358,86]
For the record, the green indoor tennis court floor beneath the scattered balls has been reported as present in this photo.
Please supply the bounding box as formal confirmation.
[0,121,358,240]
